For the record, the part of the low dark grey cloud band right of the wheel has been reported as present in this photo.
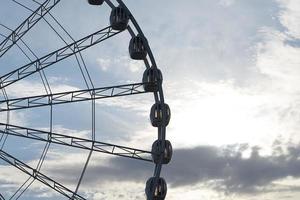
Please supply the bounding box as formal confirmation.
[165,142,300,192]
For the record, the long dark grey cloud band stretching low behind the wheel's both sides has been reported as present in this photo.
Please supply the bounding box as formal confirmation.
[45,141,300,193]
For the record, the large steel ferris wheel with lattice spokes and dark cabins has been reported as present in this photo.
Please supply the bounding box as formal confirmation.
[0,0,172,200]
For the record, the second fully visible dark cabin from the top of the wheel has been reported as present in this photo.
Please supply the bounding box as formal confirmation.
[129,35,147,60]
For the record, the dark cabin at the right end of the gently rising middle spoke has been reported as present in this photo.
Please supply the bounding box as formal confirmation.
[143,67,163,92]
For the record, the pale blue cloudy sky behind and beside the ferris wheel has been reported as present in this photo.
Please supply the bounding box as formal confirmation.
[0,0,300,200]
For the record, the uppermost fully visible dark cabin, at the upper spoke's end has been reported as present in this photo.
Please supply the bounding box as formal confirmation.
[109,6,129,31]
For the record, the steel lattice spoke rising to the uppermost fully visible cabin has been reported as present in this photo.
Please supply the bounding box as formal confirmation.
[0,26,122,89]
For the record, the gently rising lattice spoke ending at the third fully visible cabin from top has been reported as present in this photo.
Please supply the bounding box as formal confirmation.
[0,83,146,112]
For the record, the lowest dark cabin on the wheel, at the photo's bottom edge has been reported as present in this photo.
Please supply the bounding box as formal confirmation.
[145,177,167,200]
